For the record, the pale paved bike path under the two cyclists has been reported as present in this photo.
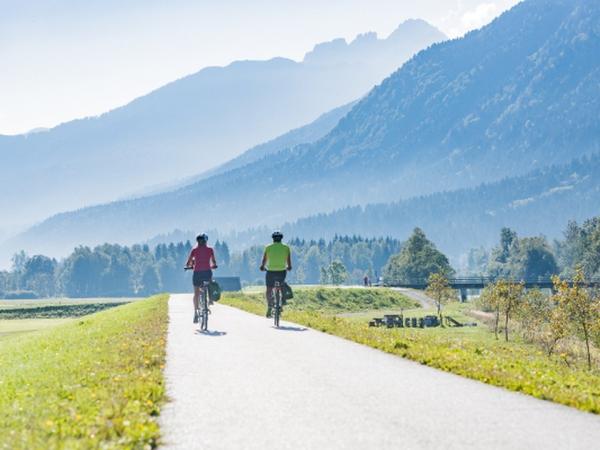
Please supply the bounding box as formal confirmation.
[160,295,600,450]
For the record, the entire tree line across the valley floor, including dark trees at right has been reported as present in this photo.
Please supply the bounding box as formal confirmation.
[0,218,600,297]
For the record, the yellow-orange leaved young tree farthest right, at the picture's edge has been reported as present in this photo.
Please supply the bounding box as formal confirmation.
[552,268,600,369]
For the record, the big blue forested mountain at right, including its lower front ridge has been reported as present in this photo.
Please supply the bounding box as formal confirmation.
[2,0,600,264]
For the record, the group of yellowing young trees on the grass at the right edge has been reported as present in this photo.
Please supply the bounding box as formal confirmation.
[480,268,600,369]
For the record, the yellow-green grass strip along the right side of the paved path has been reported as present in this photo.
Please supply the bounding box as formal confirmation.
[222,290,600,414]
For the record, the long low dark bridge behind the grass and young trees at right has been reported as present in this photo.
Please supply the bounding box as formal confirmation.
[386,277,600,302]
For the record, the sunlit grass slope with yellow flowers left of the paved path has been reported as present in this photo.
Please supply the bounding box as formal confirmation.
[0,295,168,449]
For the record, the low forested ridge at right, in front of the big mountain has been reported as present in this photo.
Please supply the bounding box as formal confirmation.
[284,155,600,261]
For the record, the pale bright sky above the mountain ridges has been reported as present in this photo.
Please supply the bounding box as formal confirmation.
[0,0,518,134]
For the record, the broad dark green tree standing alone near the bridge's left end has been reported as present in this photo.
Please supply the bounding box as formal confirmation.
[383,228,454,284]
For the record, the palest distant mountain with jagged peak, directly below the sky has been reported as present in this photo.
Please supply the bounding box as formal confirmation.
[0,21,444,228]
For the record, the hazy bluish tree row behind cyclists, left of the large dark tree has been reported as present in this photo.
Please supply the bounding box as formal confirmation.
[0,236,401,297]
